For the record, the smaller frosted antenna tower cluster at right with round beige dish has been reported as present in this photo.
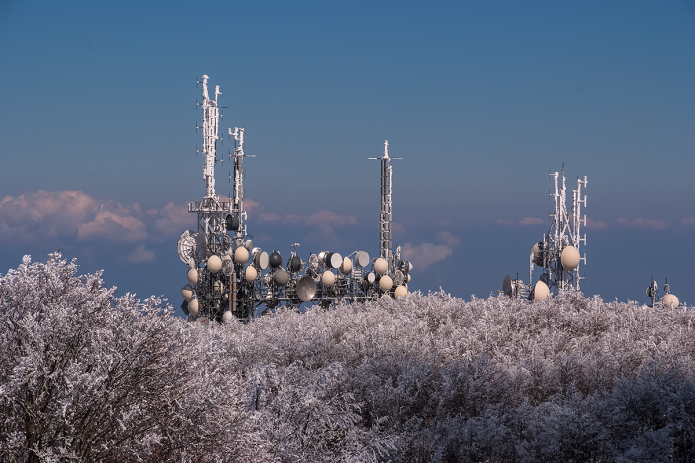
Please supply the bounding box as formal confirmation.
[529,166,588,298]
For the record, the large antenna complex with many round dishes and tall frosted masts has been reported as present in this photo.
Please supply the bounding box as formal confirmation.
[178,75,413,322]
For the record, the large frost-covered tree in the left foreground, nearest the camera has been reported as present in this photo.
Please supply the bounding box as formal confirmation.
[0,254,262,461]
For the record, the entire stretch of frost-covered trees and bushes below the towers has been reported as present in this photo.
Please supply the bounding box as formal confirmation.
[0,255,695,462]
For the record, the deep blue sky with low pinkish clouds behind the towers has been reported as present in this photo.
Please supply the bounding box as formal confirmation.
[0,0,695,306]
